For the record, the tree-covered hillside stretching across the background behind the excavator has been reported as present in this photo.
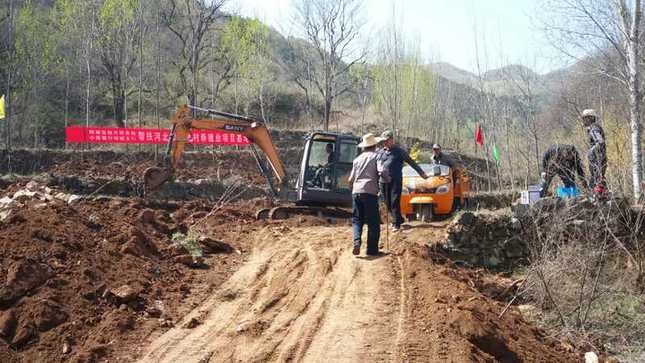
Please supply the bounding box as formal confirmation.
[0,0,630,198]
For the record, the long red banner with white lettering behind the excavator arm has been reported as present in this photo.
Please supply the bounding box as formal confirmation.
[65,126,251,145]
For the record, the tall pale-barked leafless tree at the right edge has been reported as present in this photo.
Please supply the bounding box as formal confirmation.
[543,0,643,200]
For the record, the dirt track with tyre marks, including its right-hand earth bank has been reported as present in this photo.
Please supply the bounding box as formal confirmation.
[136,226,575,363]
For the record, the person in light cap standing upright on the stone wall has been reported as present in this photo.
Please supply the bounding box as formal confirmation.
[582,109,607,195]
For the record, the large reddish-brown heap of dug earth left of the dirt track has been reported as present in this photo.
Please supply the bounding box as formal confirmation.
[0,182,255,362]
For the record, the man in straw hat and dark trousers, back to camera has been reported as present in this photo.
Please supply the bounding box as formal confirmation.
[349,133,389,256]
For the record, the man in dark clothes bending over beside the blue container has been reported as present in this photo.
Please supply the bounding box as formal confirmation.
[542,145,587,196]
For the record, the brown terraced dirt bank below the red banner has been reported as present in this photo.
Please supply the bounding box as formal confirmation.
[0,150,269,200]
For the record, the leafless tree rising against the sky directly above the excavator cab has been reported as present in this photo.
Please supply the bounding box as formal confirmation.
[296,0,365,130]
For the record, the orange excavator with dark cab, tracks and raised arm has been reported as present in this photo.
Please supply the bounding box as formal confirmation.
[143,105,359,219]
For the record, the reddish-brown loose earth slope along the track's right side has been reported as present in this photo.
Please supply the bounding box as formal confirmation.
[403,243,580,362]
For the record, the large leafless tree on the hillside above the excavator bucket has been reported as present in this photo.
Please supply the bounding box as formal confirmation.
[162,0,226,105]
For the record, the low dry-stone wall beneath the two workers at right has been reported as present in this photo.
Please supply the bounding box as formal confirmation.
[443,198,644,268]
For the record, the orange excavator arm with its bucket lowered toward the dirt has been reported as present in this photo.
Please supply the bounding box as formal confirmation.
[144,105,286,192]
